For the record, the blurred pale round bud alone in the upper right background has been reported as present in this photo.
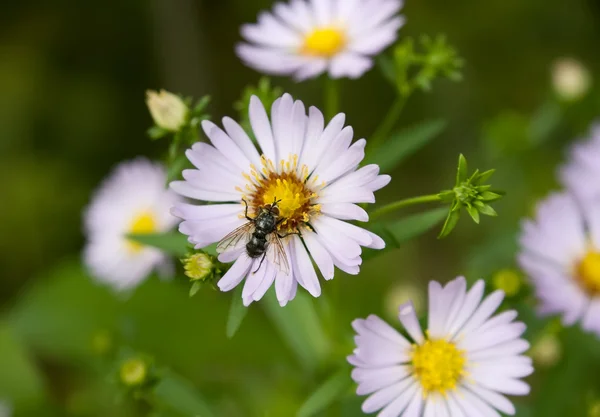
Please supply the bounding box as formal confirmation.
[552,58,592,101]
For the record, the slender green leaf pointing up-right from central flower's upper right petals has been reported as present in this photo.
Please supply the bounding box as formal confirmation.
[365,119,446,172]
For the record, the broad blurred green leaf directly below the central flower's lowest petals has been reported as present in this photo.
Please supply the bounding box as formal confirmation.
[261,289,331,370]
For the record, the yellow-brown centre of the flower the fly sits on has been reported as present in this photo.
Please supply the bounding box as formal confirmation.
[237,155,325,234]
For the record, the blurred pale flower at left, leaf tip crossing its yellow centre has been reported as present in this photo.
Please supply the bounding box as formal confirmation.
[84,158,181,290]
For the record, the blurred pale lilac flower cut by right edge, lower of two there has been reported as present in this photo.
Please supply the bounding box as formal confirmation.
[519,193,600,335]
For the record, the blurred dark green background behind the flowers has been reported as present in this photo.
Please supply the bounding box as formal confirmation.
[0,0,600,417]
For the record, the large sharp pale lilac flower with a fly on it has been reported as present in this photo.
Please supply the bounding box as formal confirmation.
[171,94,390,305]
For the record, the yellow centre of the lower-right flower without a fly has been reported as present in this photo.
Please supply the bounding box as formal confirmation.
[412,340,465,395]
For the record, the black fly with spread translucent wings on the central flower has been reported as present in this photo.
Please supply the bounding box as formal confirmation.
[217,200,290,274]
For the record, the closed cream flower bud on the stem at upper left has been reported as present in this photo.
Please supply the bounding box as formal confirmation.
[146,90,189,132]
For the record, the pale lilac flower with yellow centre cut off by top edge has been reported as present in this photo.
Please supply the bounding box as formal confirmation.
[236,0,404,81]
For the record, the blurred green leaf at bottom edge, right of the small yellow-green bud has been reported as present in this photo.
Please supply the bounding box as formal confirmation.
[154,372,216,417]
